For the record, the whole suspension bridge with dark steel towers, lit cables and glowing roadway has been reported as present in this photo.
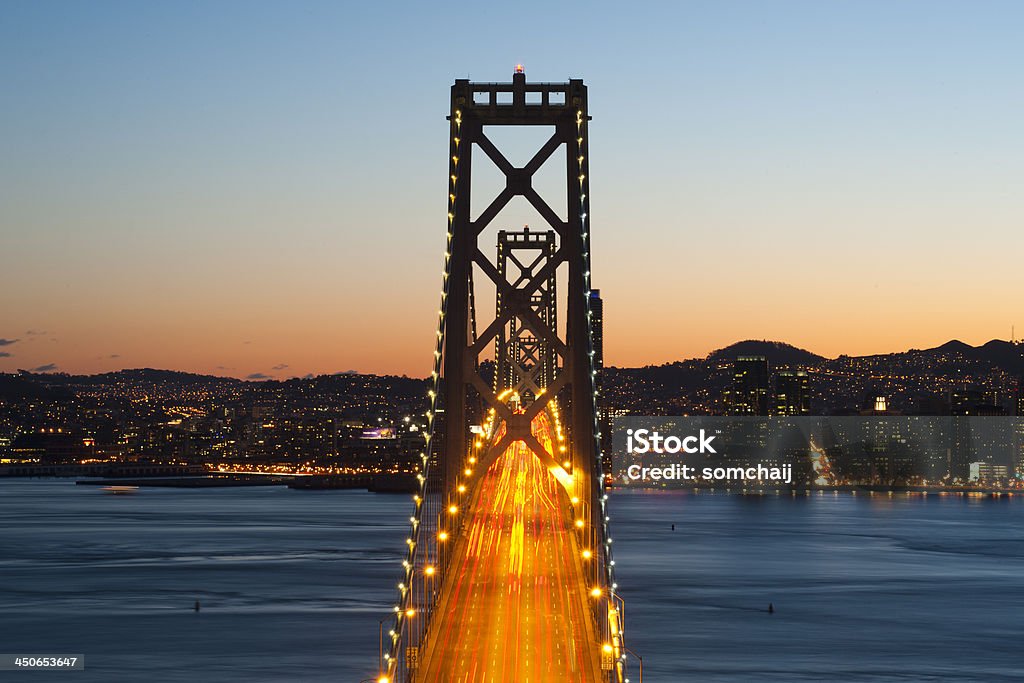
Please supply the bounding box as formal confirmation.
[377,67,628,683]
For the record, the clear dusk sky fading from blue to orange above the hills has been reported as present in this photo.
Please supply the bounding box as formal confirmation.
[0,0,1024,378]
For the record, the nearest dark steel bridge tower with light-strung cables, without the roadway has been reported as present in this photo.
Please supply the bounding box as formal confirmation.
[381,67,625,683]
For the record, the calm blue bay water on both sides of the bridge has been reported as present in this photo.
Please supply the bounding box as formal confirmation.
[0,480,1024,683]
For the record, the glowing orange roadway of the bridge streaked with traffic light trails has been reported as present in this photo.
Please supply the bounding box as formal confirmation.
[415,414,601,683]
